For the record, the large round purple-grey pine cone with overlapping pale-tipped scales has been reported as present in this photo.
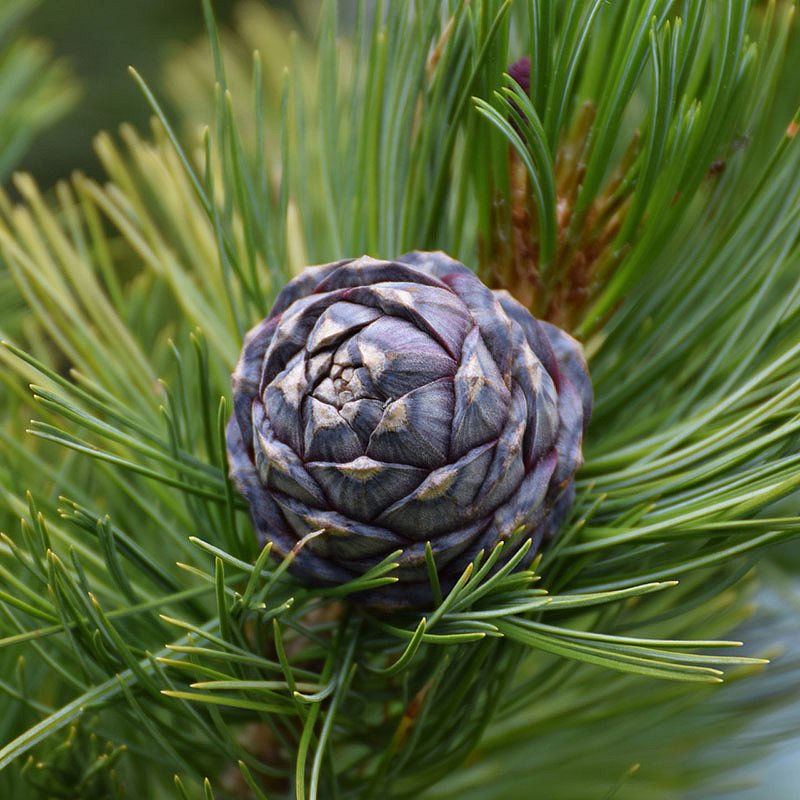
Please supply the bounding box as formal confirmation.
[227,252,592,609]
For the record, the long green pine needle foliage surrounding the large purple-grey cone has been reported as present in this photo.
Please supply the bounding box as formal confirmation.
[0,0,800,798]
